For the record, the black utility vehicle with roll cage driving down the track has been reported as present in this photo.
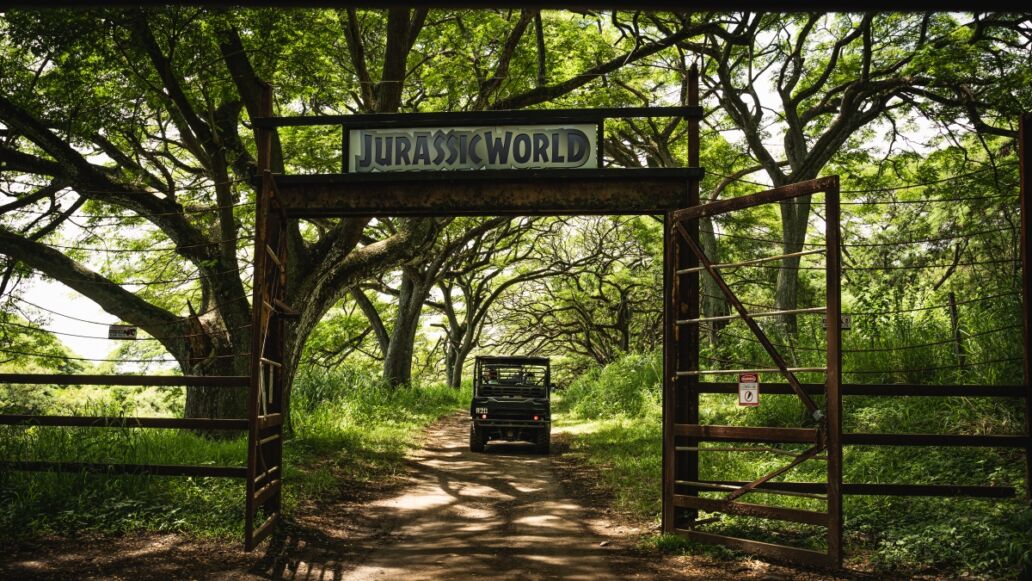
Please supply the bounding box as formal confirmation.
[470,357,552,454]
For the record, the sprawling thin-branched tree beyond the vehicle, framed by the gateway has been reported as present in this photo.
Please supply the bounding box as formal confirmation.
[485,217,663,375]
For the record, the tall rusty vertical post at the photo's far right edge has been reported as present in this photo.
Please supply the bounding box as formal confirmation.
[1018,114,1032,503]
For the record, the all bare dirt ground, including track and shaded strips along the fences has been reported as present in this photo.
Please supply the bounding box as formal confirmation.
[0,415,879,581]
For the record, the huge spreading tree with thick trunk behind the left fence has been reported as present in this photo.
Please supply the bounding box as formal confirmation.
[0,8,699,417]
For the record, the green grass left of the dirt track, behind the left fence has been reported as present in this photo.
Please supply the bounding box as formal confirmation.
[0,372,469,541]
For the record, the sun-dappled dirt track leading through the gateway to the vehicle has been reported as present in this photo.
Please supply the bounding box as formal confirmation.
[345,418,617,581]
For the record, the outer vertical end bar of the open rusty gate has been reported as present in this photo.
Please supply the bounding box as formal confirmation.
[824,175,842,568]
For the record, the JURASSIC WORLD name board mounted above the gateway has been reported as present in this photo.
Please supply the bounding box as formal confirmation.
[346,124,599,173]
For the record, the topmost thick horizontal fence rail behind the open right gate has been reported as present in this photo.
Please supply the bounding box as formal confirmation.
[698,382,1026,397]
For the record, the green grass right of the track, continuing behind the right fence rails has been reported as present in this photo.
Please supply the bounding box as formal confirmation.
[555,356,1032,578]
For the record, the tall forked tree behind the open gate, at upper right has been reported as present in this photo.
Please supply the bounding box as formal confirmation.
[653,13,1032,326]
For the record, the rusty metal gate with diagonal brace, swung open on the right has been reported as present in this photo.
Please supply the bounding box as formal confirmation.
[663,176,842,567]
